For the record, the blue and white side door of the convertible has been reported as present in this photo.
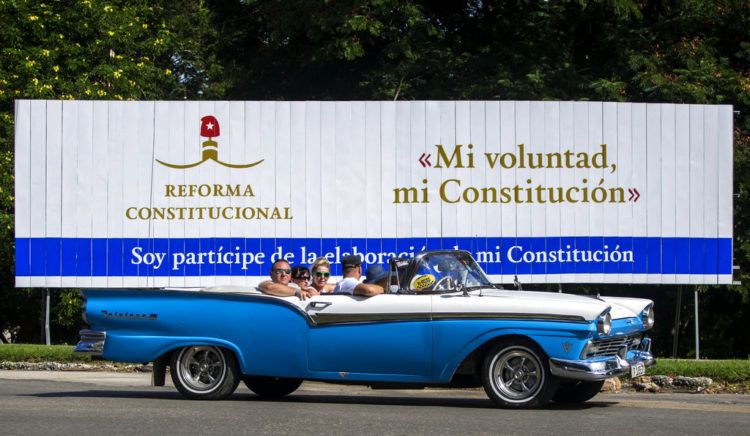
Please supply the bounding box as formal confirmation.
[305,294,432,381]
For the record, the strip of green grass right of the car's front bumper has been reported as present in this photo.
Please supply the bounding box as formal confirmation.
[646,358,750,383]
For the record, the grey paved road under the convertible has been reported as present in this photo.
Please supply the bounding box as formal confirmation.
[0,371,750,436]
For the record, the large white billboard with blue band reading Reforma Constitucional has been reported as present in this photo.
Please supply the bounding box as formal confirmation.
[15,100,733,288]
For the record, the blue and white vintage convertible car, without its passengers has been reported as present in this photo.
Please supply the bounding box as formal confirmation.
[76,251,655,408]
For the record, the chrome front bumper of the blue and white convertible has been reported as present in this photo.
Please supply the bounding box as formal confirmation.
[549,350,656,381]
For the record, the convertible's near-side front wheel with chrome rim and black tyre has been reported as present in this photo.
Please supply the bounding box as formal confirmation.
[482,340,557,408]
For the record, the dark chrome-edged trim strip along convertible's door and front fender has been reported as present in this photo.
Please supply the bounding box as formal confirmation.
[311,312,588,325]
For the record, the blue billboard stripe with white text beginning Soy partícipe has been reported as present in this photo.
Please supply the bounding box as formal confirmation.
[16,236,732,277]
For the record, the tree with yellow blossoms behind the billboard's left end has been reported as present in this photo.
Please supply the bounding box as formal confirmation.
[0,0,223,341]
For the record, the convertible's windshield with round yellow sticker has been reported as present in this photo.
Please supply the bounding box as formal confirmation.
[409,252,492,292]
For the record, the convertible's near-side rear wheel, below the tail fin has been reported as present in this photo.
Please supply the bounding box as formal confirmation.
[171,345,240,400]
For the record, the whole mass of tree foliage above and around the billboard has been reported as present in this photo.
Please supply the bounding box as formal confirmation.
[0,0,750,356]
